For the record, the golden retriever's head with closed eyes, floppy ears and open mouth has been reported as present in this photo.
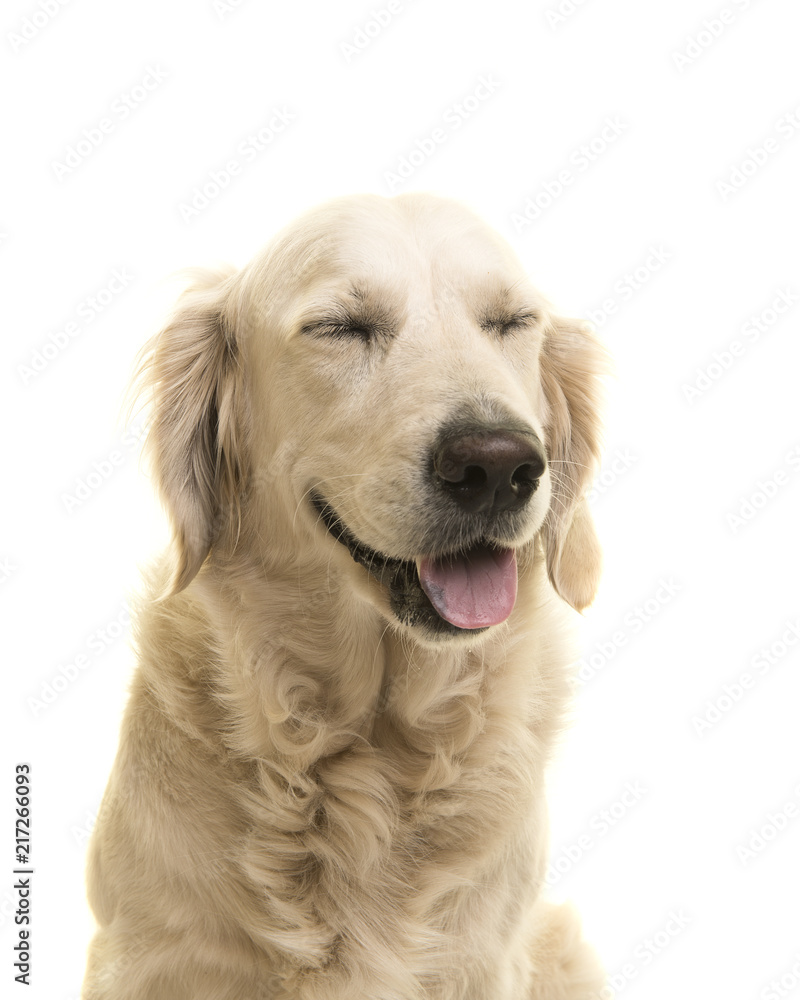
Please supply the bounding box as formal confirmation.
[136,194,604,641]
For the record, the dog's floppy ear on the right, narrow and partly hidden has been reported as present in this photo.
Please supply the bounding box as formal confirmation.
[541,317,609,611]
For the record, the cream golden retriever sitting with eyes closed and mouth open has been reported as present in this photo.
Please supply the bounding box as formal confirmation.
[83,194,605,1000]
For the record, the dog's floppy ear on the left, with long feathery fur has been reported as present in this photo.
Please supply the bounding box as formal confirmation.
[137,271,243,596]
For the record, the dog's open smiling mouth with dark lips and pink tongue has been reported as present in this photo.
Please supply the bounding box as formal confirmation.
[311,494,517,634]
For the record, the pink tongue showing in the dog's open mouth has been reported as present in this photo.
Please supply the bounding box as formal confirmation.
[419,545,517,628]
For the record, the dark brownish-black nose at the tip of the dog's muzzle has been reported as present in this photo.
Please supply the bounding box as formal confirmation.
[433,431,547,514]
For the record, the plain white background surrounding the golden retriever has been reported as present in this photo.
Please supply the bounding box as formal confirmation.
[0,0,800,1000]
